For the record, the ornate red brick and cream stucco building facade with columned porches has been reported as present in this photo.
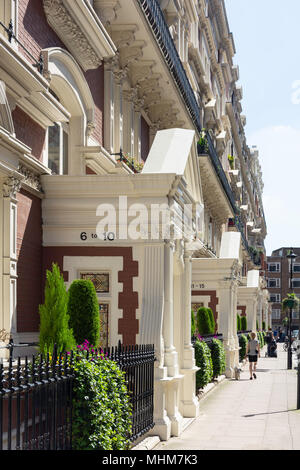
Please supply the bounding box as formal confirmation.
[0,0,269,439]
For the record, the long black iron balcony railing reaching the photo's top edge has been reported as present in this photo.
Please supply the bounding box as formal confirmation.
[138,0,202,132]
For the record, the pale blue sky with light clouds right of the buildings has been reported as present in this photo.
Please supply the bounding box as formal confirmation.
[225,0,300,255]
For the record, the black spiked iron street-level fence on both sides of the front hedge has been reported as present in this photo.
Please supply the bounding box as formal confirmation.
[0,343,155,450]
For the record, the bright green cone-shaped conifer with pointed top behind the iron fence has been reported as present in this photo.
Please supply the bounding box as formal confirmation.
[39,263,76,355]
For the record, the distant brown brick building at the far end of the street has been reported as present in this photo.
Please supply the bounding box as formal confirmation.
[267,247,300,329]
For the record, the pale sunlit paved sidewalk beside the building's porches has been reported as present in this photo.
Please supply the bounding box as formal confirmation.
[153,343,300,451]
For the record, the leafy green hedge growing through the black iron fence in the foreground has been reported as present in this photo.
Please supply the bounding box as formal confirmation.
[72,346,131,450]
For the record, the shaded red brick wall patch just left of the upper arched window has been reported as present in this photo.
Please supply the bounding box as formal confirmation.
[12,107,46,161]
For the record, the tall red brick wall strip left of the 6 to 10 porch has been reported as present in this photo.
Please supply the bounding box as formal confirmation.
[17,190,42,333]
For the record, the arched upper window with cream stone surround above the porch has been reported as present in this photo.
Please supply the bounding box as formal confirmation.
[43,48,94,176]
